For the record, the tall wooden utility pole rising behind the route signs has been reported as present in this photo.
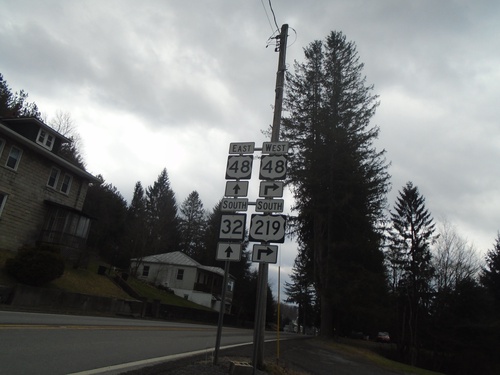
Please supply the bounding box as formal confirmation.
[253,24,288,375]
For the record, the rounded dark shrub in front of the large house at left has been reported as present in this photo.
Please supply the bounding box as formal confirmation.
[5,247,64,286]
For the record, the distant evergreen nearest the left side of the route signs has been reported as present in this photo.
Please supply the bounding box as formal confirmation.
[180,191,206,259]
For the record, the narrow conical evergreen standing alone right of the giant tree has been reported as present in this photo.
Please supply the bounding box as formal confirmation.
[388,182,436,365]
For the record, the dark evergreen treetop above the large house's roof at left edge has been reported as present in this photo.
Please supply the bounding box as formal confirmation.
[0,73,42,120]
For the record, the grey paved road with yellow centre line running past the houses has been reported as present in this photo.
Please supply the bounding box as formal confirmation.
[0,311,292,375]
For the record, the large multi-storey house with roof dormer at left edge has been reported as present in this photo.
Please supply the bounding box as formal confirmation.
[0,118,100,260]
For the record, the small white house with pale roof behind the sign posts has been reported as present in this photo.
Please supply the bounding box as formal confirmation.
[131,251,235,313]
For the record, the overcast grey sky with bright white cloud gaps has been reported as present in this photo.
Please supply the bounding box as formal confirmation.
[0,0,500,300]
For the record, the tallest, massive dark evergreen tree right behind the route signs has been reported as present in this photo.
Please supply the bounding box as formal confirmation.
[282,32,389,336]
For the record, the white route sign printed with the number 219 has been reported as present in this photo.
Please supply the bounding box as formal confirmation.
[249,214,286,243]
